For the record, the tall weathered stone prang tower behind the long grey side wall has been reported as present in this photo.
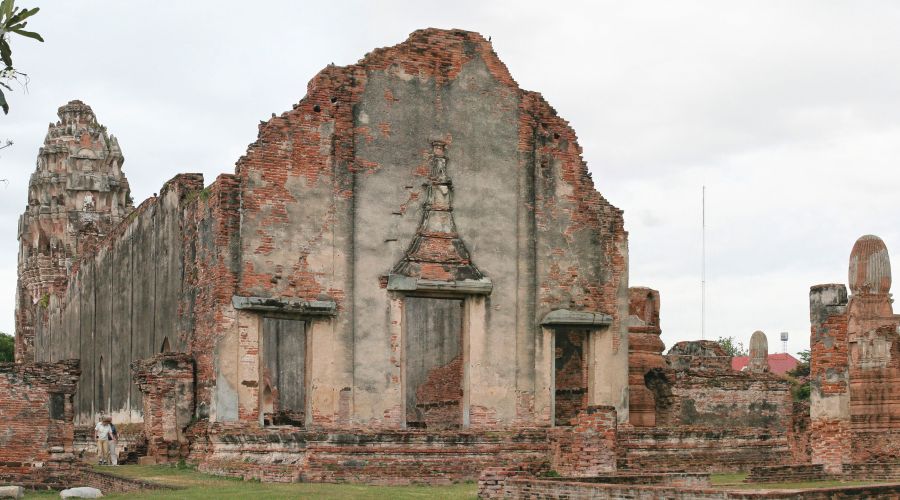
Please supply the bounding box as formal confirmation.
[16,101,132,362]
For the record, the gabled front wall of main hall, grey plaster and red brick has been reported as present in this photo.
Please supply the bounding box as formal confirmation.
[227,30,627,427]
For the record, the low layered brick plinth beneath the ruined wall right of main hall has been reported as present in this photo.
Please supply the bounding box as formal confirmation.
[618,426,792,472]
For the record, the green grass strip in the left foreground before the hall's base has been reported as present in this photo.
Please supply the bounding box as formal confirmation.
[25,465,478,500]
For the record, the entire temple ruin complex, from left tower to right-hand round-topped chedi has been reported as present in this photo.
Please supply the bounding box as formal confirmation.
[7,29,900,496]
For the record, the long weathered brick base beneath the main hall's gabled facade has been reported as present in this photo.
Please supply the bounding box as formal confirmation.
[189,425,549,484]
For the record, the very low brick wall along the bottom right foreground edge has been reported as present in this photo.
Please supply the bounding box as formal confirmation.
[496,477,900,500]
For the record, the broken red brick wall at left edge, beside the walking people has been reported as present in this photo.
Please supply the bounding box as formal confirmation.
[0,360,79,485]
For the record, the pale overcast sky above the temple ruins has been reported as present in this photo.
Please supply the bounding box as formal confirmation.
[0,0,900,358]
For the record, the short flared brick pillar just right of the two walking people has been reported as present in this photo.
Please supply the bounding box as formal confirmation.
[131,353,194,462]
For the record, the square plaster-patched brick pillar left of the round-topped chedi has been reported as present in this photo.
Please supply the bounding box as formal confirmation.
[809,284,852,472]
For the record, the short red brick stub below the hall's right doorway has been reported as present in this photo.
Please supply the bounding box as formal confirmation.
[550,406,618,477]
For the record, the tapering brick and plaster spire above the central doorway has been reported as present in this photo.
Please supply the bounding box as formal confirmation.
[389,141,486,289]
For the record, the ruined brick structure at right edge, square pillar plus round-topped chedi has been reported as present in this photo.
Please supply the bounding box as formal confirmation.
[809,235,900,470]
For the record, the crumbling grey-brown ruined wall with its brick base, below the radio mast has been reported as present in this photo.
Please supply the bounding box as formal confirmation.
[618,341,792,471]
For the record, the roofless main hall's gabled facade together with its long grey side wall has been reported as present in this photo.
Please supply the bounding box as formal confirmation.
[28,30,628,434]
